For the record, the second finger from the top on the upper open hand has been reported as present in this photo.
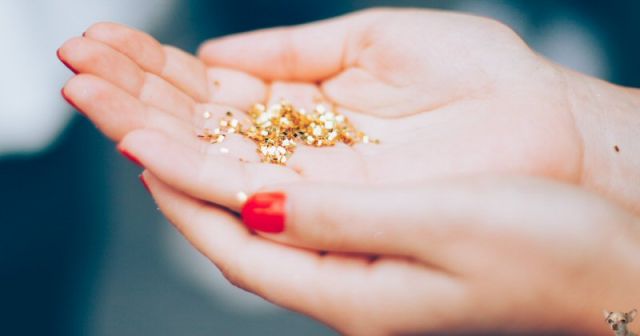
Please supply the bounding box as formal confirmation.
[58,38,194,120]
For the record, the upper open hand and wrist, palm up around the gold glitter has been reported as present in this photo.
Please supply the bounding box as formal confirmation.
[60,10,640,214]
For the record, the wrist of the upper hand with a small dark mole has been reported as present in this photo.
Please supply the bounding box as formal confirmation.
[562,70,640,214]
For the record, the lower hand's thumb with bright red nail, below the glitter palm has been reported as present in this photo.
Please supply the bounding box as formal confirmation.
[242,184,440,255]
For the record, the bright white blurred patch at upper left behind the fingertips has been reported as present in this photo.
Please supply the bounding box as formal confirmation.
[0,0,177,155]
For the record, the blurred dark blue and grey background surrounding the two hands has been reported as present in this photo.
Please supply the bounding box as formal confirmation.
[0,0,640,336]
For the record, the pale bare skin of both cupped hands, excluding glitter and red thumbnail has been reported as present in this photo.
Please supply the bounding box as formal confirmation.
[59,10,640,335]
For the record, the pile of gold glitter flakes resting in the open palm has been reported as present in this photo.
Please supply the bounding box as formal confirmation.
[198,101,379,165]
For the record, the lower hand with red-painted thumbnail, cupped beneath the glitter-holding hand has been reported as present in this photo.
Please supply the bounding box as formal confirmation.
[143,172,640,335]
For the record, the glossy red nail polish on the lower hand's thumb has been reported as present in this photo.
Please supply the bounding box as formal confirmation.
[242,192,286,233]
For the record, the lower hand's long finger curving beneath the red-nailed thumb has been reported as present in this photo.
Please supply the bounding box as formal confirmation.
[142,171,468,334]
